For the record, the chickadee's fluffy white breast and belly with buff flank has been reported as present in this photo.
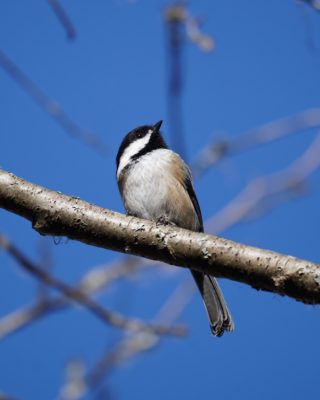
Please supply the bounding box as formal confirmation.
[122,149,199,230]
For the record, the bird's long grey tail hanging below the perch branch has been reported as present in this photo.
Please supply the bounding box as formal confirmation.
[191,271,234,336]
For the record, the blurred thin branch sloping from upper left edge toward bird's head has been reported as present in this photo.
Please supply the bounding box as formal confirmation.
[0,50,107,156]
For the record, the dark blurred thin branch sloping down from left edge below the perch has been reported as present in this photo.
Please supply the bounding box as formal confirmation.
[0,236,185,336]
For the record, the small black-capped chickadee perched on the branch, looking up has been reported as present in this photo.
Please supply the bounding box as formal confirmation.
[116,120,234,337]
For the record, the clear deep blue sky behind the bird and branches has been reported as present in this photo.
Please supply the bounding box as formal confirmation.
[0,0,320,400]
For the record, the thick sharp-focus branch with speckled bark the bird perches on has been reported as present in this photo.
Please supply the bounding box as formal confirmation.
[0,170,320,304]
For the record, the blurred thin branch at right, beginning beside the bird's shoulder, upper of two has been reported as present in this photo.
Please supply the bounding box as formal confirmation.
[191,108,320,178]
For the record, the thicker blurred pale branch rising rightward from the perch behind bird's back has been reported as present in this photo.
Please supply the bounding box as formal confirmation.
[206,134,320,233]
